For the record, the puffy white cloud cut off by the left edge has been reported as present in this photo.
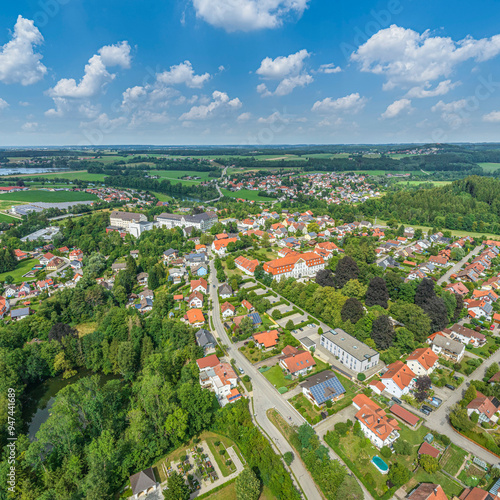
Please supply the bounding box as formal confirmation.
[0,16,47,85]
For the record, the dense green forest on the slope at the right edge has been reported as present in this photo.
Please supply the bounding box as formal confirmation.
[361,176,500,234]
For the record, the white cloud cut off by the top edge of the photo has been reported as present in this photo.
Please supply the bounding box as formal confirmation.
[193,0,309,32]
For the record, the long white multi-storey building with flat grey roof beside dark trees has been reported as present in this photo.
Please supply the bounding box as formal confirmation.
[320,328,380,373]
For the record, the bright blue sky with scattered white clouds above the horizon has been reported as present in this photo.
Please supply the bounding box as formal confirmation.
[0,0,500,146]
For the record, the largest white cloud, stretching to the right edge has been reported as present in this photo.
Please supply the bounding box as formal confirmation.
[351,25,500,89]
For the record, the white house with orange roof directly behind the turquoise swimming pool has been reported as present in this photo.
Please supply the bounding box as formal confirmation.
[352,394,400,448]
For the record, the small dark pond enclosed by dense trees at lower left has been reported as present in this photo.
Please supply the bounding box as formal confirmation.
[23,370,120,441]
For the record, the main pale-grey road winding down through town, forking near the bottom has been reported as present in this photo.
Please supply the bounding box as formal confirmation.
[210,259,373,500]
